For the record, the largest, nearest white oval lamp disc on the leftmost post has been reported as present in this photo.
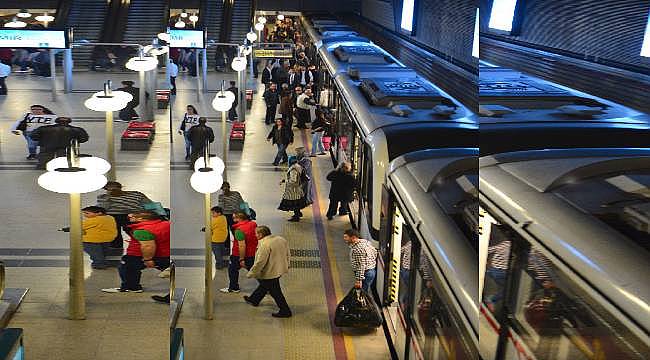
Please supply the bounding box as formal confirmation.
[37,171,108,194]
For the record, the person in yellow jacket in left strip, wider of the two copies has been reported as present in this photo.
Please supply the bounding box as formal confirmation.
[81,206,117,269]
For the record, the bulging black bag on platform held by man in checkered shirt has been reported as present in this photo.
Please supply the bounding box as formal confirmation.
[334,288,382,328]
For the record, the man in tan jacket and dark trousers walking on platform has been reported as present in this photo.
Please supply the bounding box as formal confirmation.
[244,225,292,318]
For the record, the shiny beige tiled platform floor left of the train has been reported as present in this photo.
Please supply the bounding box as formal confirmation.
[0,69,390,359]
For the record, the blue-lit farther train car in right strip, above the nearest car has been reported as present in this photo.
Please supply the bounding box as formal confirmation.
[478,62,650,155]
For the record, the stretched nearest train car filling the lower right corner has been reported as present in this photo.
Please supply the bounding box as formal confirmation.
[479,148,650,360]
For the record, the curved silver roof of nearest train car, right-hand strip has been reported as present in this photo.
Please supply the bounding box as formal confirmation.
[480,148,650,338]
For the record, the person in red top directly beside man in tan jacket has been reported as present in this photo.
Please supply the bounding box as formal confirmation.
[219,211,257,293]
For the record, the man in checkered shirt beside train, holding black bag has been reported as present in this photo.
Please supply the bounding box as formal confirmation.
[343,229,377,292]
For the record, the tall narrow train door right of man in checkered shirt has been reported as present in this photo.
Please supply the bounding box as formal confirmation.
[376,188,419,359]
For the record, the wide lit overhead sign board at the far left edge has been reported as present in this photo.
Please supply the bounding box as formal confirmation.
[0,29,66,49]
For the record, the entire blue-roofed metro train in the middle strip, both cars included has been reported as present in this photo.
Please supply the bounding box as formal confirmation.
[302,12,479,359]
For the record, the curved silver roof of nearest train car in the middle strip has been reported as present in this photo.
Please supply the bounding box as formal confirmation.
[387,148,479,340]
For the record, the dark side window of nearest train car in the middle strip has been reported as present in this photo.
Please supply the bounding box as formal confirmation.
[411,252,478,360]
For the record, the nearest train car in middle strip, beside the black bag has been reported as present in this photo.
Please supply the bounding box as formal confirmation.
[377,148,479,360]
